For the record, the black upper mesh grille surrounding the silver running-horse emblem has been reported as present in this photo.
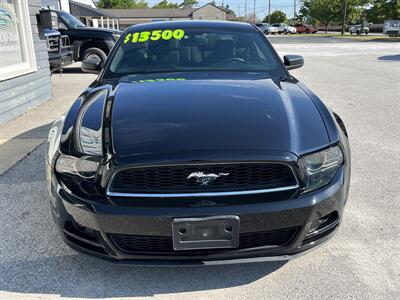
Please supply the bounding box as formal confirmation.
[109,163,297,194]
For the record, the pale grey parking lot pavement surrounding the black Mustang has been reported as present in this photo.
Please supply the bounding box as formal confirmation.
[0,37,400,299]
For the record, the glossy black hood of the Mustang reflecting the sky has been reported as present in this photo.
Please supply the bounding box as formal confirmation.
[111,73,329,156]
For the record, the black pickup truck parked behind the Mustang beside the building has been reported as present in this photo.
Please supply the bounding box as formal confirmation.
[56,11,122,71]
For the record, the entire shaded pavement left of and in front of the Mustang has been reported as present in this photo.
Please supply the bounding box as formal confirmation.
[0,144,286,298]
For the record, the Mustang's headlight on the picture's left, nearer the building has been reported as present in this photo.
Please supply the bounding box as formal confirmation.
[55,154,99,180]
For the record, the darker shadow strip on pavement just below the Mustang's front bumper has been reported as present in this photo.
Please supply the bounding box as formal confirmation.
[0,255,285,298]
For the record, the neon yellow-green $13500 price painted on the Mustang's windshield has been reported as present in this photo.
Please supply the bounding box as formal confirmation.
[124,29,185,44]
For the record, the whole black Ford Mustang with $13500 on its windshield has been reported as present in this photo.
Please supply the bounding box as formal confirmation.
[47,21,350,264]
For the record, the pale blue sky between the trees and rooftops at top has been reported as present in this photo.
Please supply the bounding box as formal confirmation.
[147,0,300,19]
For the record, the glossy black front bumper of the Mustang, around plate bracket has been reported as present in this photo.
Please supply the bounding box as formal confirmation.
[49,168,348,265]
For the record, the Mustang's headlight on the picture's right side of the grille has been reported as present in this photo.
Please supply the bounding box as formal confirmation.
[300,146,343,192]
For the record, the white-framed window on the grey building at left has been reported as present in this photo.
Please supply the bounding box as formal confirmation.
[0,0,37,81]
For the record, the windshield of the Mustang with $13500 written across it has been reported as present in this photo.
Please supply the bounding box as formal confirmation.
[103,28,285,79]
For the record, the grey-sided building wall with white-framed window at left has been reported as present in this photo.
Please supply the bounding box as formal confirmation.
[0,0,59,124]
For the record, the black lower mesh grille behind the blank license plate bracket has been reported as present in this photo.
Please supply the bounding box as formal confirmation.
[109,227,299,255]
